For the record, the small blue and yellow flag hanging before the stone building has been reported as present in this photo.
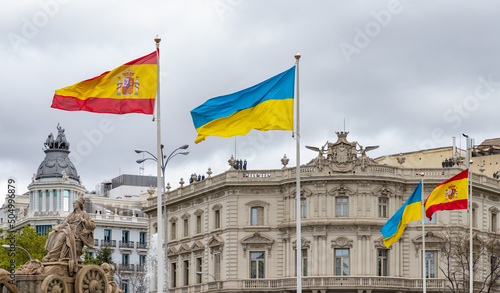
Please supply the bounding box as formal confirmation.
[380,182,422,248]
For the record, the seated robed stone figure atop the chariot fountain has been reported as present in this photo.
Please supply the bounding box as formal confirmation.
[43,197,96,273]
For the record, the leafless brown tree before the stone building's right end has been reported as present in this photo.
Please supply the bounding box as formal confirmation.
[439,226,500,293]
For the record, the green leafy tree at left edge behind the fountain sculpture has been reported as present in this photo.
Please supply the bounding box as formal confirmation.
[0,226,47,270]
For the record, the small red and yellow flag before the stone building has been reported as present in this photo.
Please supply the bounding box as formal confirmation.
[424,169,469,219]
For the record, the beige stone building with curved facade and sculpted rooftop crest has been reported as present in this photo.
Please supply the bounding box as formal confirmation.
[144,132,500,293]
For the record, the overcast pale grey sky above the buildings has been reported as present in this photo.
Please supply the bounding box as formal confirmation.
[0,0,500,204]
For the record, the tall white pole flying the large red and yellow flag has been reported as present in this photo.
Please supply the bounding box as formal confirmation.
[155,36,164,293]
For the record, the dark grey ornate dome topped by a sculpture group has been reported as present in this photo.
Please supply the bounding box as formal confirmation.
[36,124,80,181]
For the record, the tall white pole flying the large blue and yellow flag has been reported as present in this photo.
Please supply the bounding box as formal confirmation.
[295,52,302,293]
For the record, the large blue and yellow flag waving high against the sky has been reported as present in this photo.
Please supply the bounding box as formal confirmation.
[191,66,295,143]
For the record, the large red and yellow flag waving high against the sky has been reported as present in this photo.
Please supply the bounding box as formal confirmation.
[52,51,157,114]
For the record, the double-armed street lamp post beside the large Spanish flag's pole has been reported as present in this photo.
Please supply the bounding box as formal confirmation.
[134,144,189,293]
